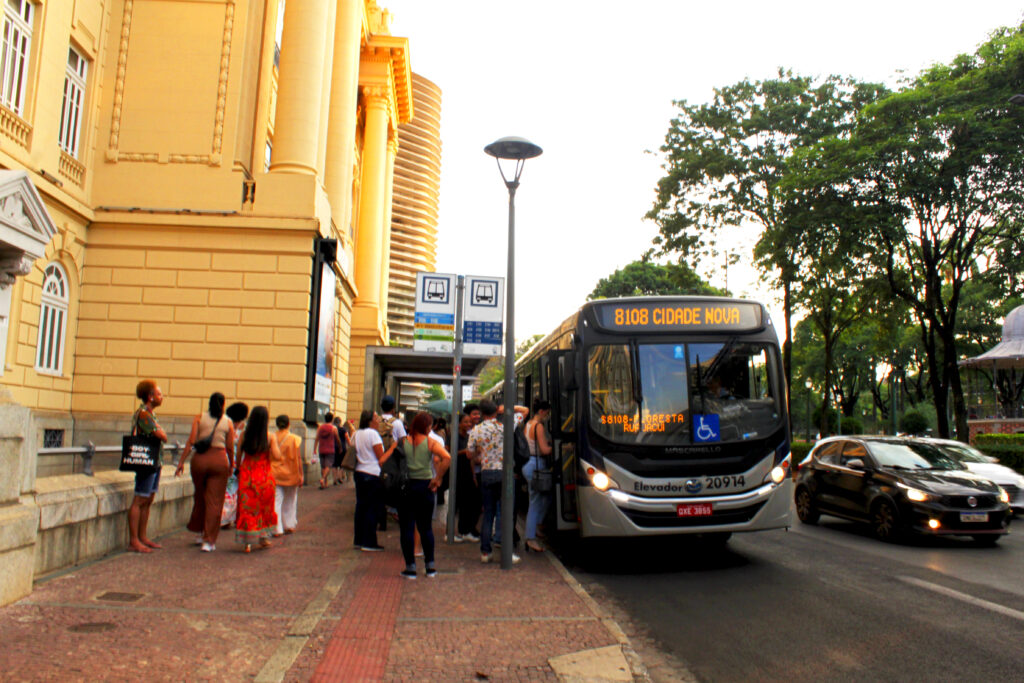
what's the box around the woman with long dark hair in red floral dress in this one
[234,405,281,553]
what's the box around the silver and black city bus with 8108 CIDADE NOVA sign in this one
[498,296,793,542]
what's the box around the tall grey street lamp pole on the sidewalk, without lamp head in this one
[502,179,519,569]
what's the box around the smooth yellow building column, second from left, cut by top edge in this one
[324,0,362,237]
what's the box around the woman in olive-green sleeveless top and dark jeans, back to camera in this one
[398,413,452,579]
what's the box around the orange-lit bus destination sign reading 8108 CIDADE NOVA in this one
[596,301,764,332]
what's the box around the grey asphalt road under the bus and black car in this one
[559,509,1024,682]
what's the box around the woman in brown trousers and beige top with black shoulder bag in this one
[174,391,234,553]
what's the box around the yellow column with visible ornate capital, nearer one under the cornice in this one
[352,86,388,341]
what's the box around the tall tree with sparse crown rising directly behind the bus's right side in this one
[647,69,885,411]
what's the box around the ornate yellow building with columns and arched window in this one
[0,0,414,602]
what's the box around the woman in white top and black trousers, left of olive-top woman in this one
[352,411,397,553]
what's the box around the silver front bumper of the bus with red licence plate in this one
[578,477,793,537]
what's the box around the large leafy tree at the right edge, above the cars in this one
[786,22,1024,438]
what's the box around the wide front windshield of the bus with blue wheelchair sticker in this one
[588,338,784,445]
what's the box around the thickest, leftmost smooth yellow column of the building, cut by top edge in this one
[270,0,330,175]
